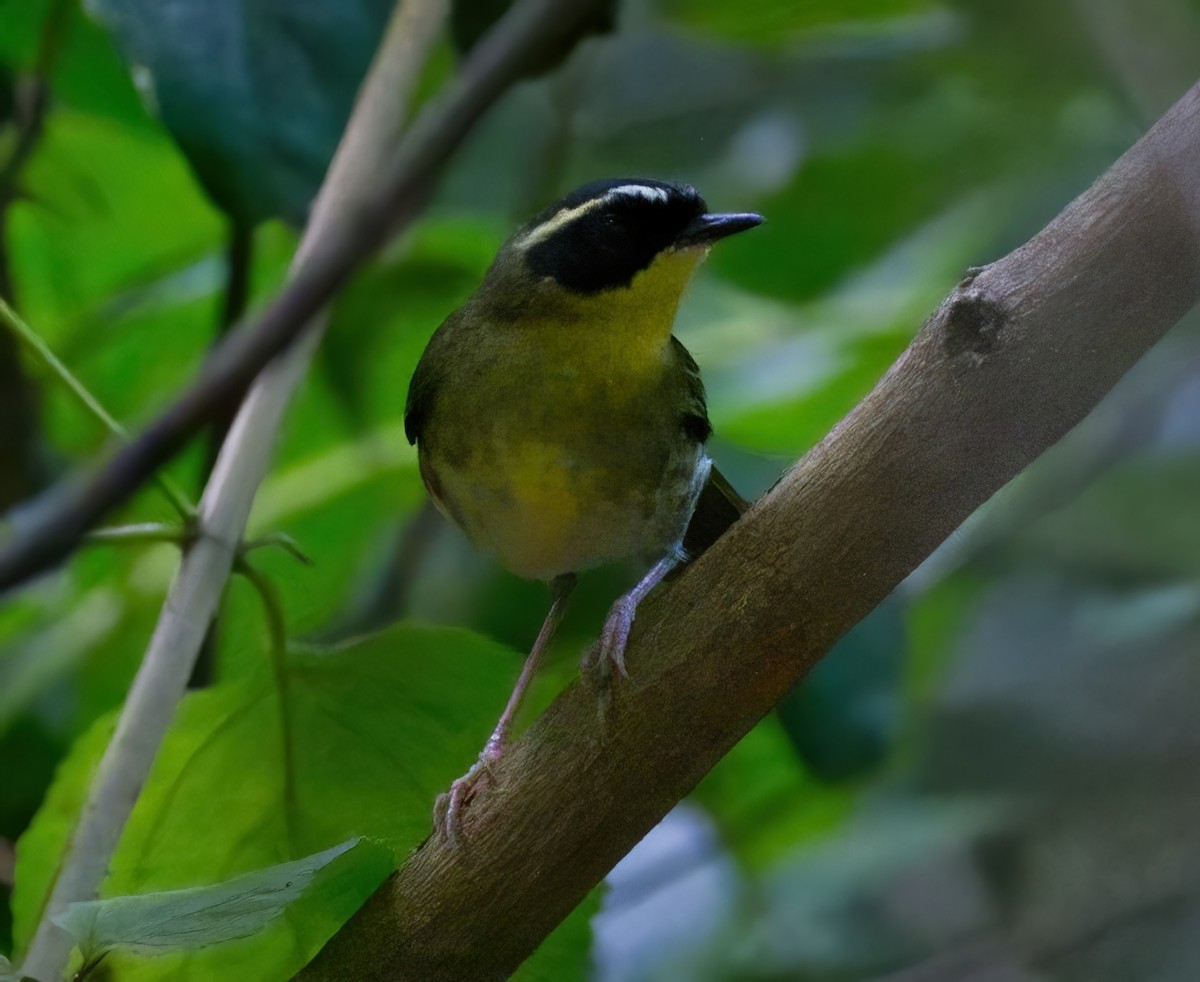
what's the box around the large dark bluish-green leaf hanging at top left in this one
[88,0,392,222]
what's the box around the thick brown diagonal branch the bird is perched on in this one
[298,78,1200,982]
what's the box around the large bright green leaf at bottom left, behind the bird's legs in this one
[13,624,530,982]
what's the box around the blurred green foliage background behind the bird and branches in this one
[0,0,1200,982]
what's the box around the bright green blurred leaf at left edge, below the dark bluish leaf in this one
[8,108,222,350]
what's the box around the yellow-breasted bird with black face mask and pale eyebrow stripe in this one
[404,178,763,843]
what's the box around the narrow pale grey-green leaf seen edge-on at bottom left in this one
[54,839,360,962]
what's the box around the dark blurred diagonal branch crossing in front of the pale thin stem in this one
[0,0,607,591]
